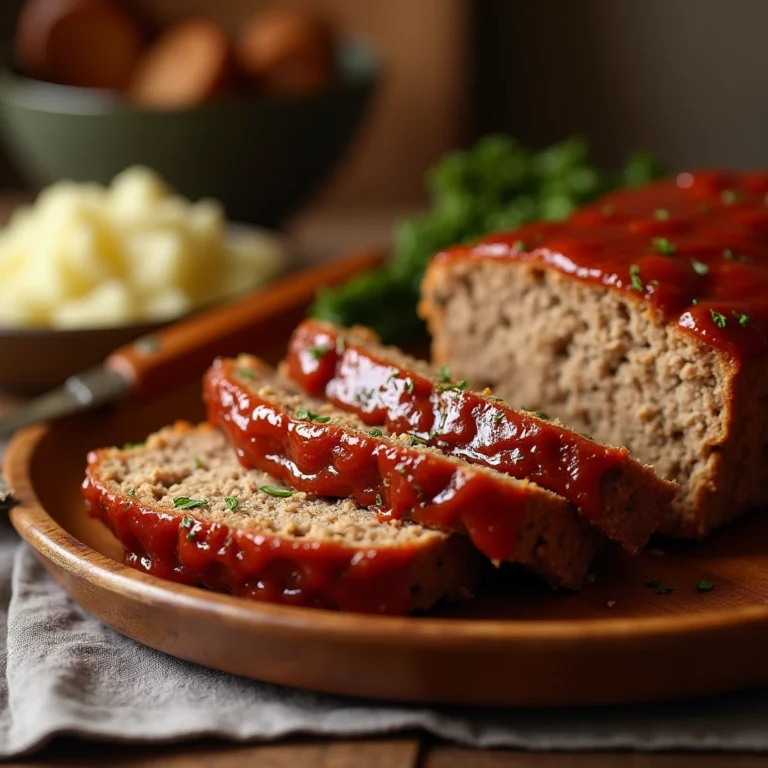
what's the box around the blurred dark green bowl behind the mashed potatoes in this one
[0,41,379,227]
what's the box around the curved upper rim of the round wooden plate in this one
[3,424,768,647]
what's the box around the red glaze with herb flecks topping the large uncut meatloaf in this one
[435,171,768,367]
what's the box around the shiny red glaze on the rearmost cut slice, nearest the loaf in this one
[286,320,674,533]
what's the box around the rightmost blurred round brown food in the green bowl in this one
[235,11,334,95]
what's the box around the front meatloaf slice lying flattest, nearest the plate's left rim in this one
[83,423,481,613]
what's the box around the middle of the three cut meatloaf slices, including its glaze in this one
[205,356,599,588]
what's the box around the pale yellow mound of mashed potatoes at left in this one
[0,167,283,328]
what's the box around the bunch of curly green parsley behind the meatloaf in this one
[311,136,660,342]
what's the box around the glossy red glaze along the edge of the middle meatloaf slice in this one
[204,360,548,560]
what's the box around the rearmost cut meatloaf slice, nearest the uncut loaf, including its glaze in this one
[285,320,675,552]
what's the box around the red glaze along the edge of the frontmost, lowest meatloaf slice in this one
[83,460,440,614]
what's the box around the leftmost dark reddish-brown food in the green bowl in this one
[16,0,143,89]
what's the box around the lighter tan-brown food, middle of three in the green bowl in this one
[129,19,229,109]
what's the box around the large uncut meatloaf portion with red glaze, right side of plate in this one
[421,172,768,537]
